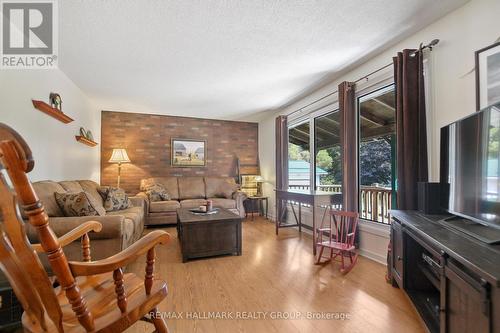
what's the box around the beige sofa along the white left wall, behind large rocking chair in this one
[26,180,144,260]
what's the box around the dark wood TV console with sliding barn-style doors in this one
[389,210,500,333]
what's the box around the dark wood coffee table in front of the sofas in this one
[177,208,243,262]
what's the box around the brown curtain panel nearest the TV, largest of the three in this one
[393,50,428,210]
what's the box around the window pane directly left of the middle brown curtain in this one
[314,110,342,193]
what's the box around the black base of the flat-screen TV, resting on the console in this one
[439,216,500,244]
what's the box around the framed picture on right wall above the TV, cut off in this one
[476,42,500,110]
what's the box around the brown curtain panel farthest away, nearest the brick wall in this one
[276,116,288,219]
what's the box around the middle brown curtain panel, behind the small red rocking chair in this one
[338,82,359,247]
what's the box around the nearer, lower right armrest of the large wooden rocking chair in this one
[69,230,170,276]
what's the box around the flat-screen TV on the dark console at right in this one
[441,104,500,228]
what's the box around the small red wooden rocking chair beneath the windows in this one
[316,208,358,274]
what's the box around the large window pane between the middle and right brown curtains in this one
[358,84,396,223]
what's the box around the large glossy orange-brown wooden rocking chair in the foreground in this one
[0,123,170,332]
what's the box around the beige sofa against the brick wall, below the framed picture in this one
[137,177,246,225]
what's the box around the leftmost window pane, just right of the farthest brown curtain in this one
[288,122,311,190]
